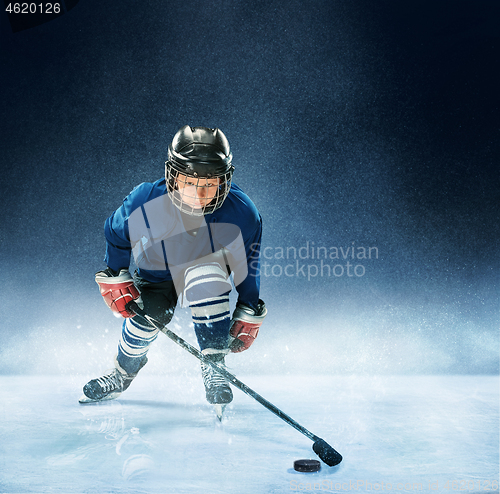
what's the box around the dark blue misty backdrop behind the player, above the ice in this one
[0,0,500,372]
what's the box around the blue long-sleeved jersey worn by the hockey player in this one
[104,179,262,308]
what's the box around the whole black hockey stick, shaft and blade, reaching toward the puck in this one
[127,302,342,467]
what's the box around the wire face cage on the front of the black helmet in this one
[165,160,234,216]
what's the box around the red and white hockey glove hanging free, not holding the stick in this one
[229,300,267,353]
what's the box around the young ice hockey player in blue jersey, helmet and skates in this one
[80,125,267,417]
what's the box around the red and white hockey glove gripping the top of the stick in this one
[95,268,142,317]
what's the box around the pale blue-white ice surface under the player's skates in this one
[0,376,499,494]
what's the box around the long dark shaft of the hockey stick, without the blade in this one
[127,302,320,441]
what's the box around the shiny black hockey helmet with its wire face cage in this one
[165,125,234,216]
